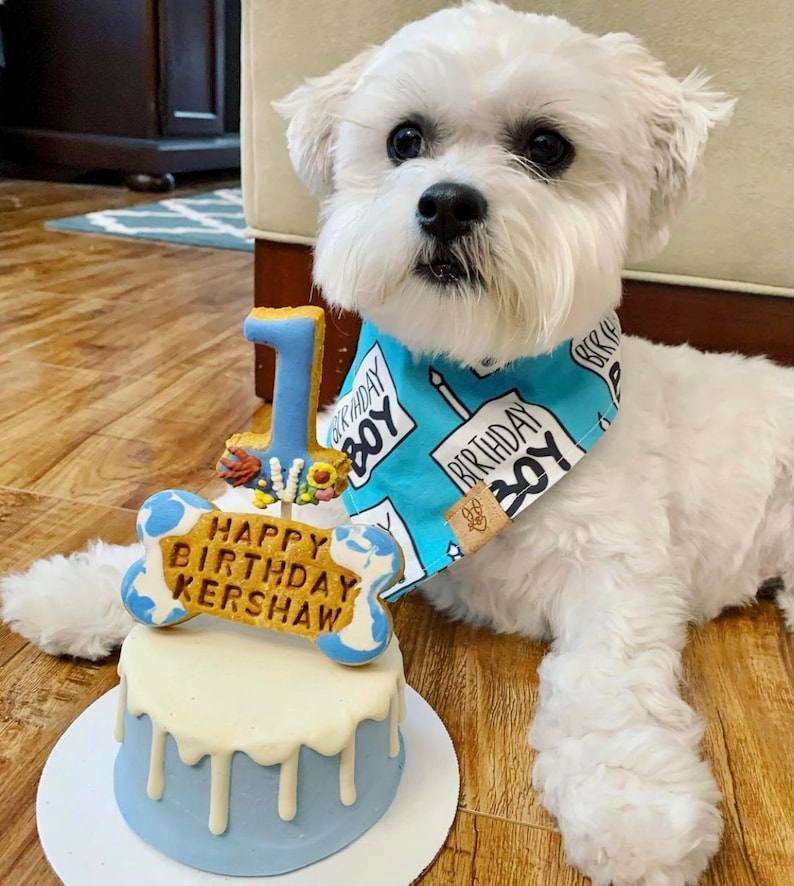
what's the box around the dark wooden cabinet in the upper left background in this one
[0,0,240,183]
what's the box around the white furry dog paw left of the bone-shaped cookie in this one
[0,541,143,660]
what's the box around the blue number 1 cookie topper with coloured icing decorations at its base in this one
[218,306,350,518]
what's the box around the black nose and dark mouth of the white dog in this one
[416,182,488,285]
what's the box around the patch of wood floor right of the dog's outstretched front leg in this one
[684,603,794,886]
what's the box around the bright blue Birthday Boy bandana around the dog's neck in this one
[328,313,620,600]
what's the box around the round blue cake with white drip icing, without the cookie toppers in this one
[114,616,405,876]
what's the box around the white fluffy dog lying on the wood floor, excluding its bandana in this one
[4,0,794,886]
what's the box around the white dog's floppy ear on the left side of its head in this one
[273,47,376,198]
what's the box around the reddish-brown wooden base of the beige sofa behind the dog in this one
[254,240,794,404]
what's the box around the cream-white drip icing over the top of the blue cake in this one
[116,616,405,834]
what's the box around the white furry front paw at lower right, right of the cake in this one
[534,734,722,886]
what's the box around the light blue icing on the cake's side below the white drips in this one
[114,713,405,877]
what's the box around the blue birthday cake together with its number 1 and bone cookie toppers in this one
[114,308,405,876]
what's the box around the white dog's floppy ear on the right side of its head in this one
[601,34,736,261]
